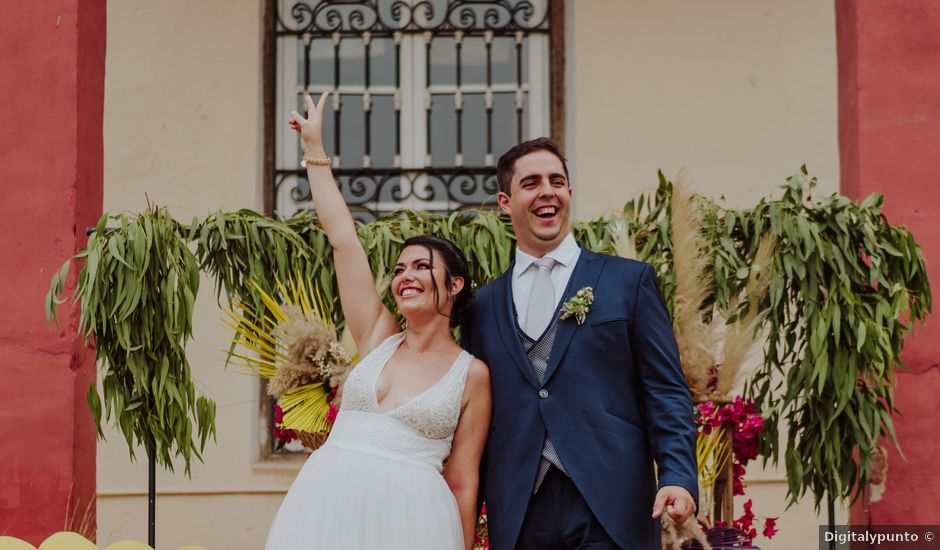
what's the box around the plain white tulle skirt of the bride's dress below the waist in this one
[265,443,463,550]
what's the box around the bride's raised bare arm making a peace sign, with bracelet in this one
[289,92,401,356]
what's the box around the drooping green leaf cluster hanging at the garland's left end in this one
[46,208,215,475]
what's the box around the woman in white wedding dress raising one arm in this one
[265,93,490,550]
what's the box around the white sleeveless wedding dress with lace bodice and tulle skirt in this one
[265,333,472,550]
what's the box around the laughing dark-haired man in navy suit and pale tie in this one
[463,138,697,550]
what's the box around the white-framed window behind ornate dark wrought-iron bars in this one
[265,0,561,221]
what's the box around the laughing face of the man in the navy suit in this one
[497,151,571,257]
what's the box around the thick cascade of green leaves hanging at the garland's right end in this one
[724,171,931,508]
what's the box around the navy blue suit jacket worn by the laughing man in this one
[462,248,698,550]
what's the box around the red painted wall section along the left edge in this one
[0,0,105,545]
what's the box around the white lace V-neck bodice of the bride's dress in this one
[326,332,473,471]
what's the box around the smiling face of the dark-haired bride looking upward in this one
[391,246,459,318]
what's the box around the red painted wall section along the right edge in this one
[836,0,940,525]
